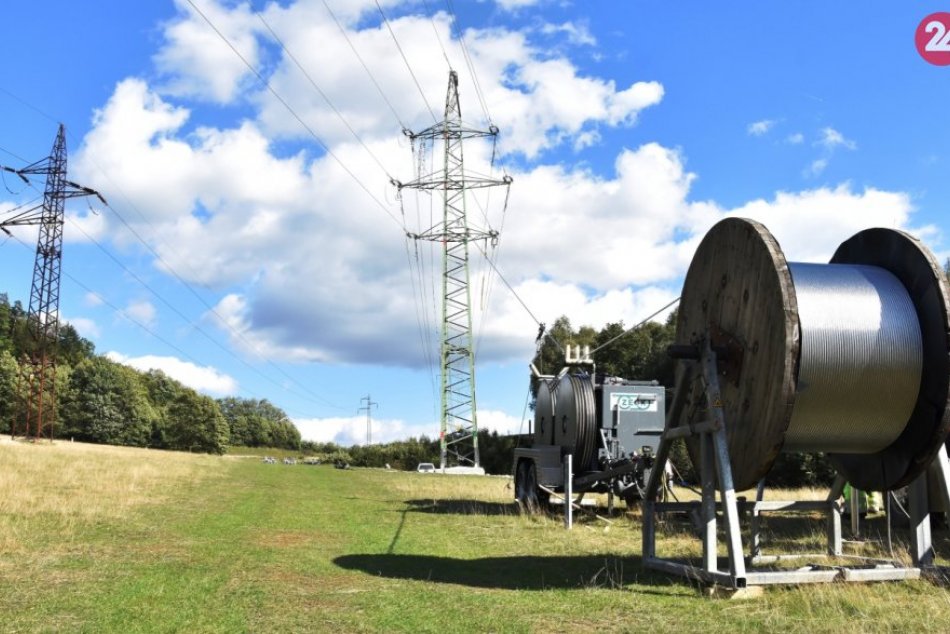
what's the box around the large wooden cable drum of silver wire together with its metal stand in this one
[643,218,950,588]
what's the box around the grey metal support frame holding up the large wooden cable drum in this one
[642,340,936,589]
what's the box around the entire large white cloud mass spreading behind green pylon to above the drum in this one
[74,1,928,380]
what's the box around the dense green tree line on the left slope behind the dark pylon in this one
[0,293,301,454]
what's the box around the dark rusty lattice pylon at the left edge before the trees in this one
[0,124,107,440]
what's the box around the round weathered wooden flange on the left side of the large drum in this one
[668,218,799,490]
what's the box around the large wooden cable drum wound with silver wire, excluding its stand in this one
[668,218,950,490]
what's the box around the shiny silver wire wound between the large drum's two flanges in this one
[784,262,923,454]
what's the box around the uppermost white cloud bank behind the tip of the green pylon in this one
[186,2,663,156]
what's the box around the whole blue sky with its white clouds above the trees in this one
[0,0,950,444]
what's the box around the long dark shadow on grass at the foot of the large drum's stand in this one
[333,555,689,594]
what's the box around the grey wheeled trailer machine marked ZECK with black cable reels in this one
[514,346,666,512]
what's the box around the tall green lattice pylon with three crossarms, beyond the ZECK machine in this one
[394,70,511,469]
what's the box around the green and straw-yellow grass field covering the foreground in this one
[0,440,950,632]
